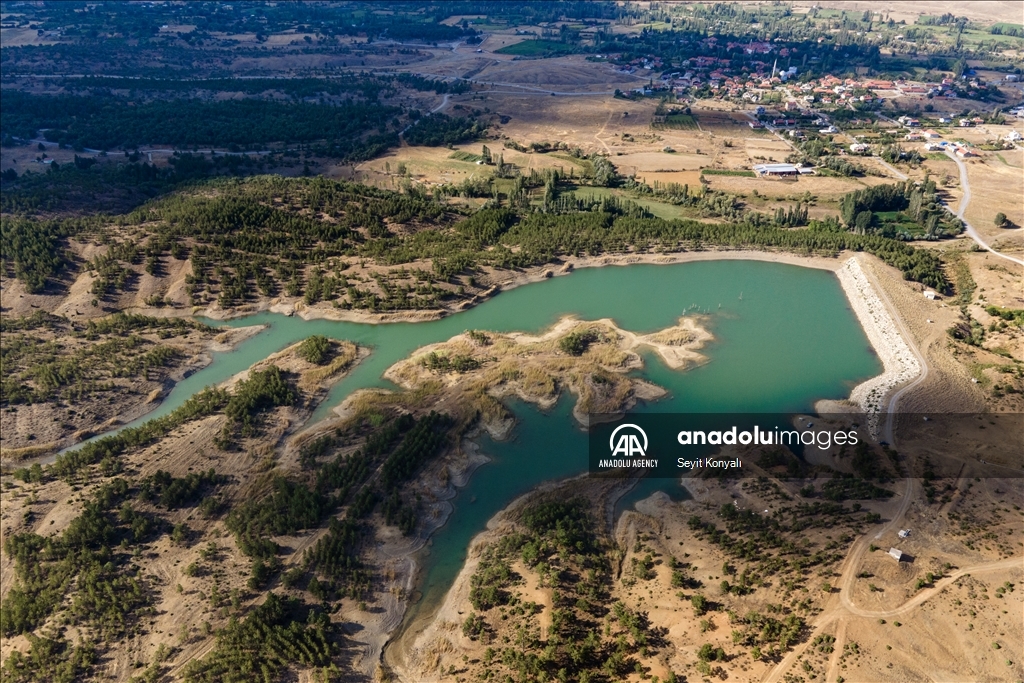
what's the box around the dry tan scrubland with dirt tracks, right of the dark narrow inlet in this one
[386,454,1024,682]
